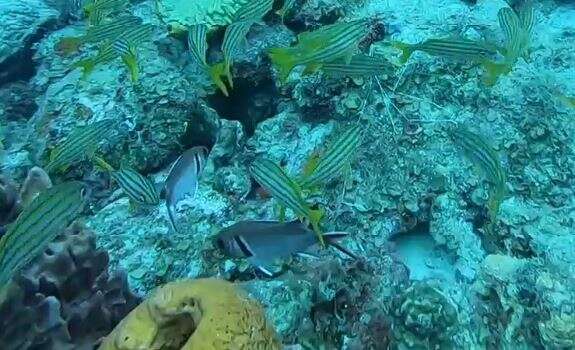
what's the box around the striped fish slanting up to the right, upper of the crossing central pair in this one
[298,125,361,188]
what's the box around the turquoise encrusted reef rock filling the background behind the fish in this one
[0,0,575,349]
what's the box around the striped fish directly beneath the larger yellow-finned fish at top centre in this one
[321,54,393,77]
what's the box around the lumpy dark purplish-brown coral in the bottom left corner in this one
[0,225,139,350]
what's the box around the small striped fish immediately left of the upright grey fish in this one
[94,157,160,205]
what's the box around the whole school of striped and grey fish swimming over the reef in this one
[0,0,536,286]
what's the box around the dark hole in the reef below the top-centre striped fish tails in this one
[208,76,279,137]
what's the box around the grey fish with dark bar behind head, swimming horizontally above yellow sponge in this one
[215,220,357,277]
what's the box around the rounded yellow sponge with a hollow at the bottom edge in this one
[100,278,281,350]
